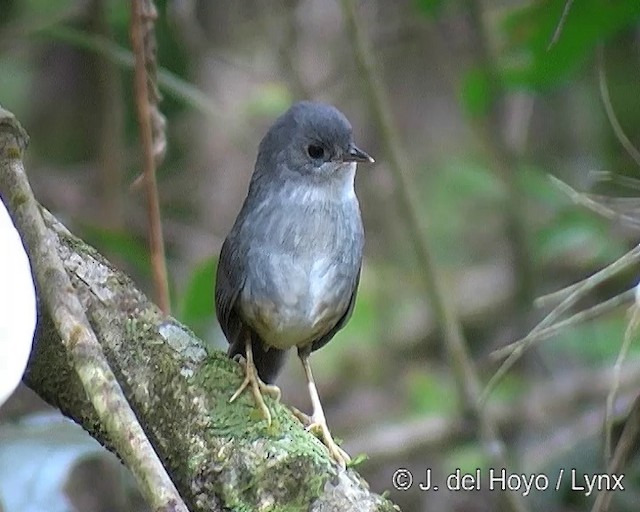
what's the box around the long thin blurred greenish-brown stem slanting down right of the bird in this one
[342,0,527,511]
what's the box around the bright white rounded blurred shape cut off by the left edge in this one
[0,196,36,406]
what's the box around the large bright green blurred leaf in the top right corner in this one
[502,0,640,89]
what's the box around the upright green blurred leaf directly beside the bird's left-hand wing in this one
[178,258,218,337]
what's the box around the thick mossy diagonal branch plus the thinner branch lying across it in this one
[0,107,397,512]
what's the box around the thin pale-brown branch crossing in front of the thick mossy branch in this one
[0,108,187,512]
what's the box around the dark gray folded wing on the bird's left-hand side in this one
[215,236,246,344]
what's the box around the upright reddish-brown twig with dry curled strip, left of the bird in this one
[131,0,171,314]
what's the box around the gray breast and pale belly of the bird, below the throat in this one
[240,190,363,349]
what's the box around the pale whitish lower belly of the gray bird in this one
[240,254,357,349]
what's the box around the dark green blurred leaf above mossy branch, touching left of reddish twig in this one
[82,225,151,277]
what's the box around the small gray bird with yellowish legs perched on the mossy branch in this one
[215,101,373,466]
